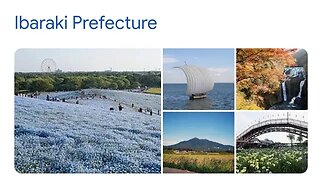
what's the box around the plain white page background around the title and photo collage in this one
[0,0,320,180]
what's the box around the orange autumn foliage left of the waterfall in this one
[236,48,296,109]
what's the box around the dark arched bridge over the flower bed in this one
[237,118,308,148]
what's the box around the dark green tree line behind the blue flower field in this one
[15,71,161,94]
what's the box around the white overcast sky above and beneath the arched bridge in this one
[236,111,308,143]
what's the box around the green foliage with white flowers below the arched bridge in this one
[237,147,308,173]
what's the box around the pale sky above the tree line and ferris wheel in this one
[15,49,161,72]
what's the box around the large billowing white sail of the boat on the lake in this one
[177,65,214,96]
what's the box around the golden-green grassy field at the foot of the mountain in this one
[163,153,234,173]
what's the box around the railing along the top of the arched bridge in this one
[237,118,308,139]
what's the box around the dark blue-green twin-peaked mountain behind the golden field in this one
[164,138,234,152]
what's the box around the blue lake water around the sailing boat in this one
[163,83,234,110]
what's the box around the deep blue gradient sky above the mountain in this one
[163,112,234,145]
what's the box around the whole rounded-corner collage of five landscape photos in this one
[14,48,308,174]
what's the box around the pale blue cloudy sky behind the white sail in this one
[163,49,234,83]
